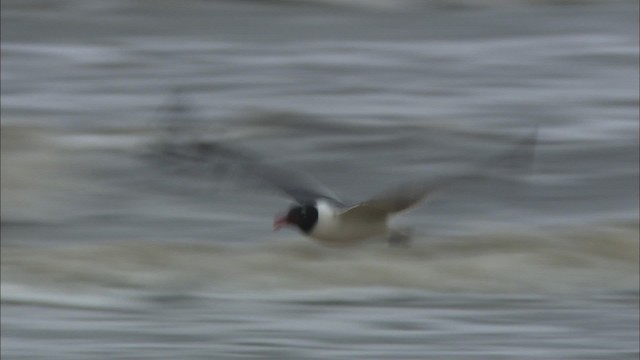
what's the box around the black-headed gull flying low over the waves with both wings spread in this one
[148,91,538,246]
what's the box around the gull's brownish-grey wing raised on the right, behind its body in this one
[342,128,538,217]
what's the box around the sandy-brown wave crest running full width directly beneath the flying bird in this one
[1,222,639,307]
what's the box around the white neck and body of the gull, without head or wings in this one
[309,200,389,246]
